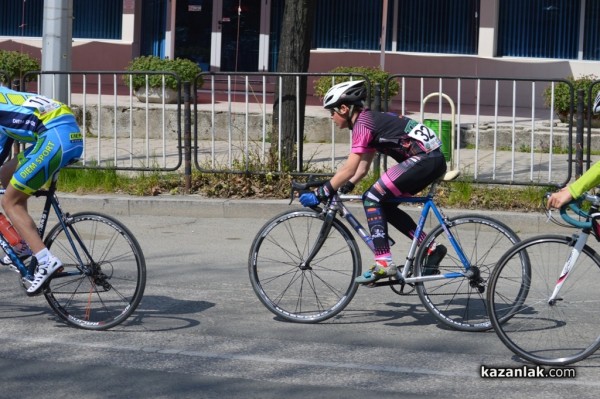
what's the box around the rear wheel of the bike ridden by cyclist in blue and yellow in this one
[43,212,146,330]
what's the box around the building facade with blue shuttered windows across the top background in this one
[0,0,600,79]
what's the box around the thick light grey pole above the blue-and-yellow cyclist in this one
[41,0,73,103]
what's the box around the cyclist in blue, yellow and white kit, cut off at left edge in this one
[0,87,83,295]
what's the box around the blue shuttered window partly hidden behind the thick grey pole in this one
[0,0,123,39]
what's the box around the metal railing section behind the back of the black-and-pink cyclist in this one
[386,75,575,184]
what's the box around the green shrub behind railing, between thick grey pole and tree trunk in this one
[123,55,203,90]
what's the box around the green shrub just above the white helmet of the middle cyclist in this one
[314,67,400,101]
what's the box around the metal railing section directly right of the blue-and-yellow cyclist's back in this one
[22,71,183,171]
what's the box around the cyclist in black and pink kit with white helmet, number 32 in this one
[300,80,446,284]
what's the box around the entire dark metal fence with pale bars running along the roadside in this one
[1,71,600,185]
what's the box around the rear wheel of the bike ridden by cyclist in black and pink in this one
[413,215,519,331]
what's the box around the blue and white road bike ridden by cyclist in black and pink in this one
[248,173,519,331]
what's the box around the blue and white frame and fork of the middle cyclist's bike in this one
[314,183,472,283]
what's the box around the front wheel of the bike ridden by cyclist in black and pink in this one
[248,210,362,323]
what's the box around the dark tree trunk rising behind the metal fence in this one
[271,0,316,170]
